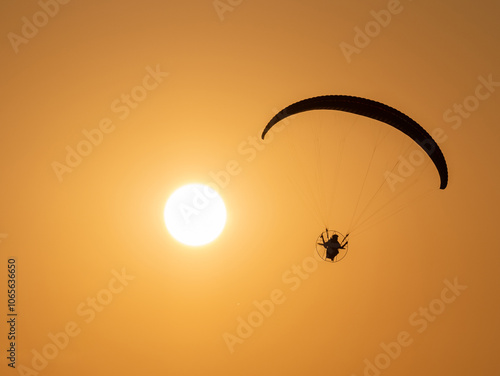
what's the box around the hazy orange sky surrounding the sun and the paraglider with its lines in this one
[0,0,500,376]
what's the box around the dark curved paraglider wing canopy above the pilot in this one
[262,95,448,189]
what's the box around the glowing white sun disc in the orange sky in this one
[164,184,227,246]
